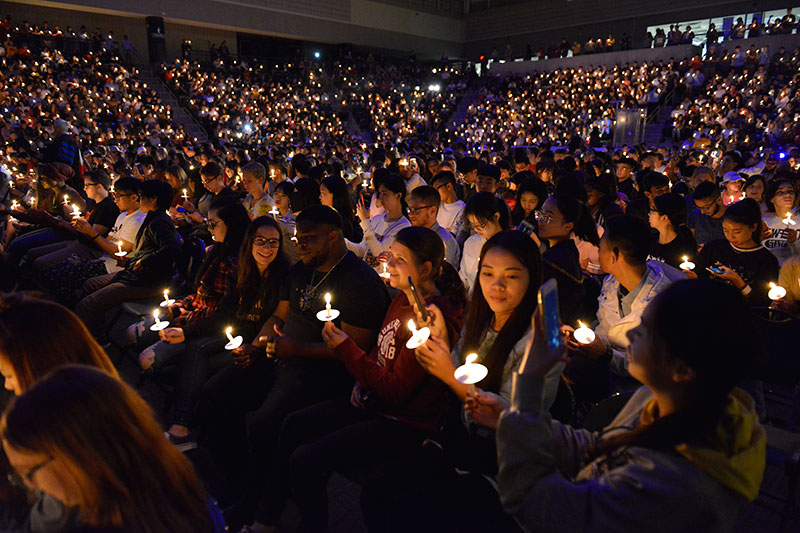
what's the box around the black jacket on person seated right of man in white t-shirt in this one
[114,211,181,287]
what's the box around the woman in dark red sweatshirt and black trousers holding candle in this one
[242,227,466,531]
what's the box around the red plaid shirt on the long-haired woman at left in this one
[175,252,238,326]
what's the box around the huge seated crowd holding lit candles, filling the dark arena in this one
[0,7,800,533]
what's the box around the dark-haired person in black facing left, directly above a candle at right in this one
[648,192,697,268]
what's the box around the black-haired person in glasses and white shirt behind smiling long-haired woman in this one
[458,192,511,292]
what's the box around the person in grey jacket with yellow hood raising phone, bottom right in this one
[497,281,766,531]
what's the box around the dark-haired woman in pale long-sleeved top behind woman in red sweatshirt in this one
[345,176,411,267]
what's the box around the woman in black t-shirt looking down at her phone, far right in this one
[689,198,779,307]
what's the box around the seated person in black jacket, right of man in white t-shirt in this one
[75,180,181,338]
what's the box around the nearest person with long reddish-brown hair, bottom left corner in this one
[0,365,225,533]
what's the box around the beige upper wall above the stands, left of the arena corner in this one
[0,0,466,58]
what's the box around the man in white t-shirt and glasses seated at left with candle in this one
[37,178,145,307]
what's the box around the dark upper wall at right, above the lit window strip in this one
[464,0,800,59]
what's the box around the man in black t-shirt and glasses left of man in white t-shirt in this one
[25,169,119,272]
